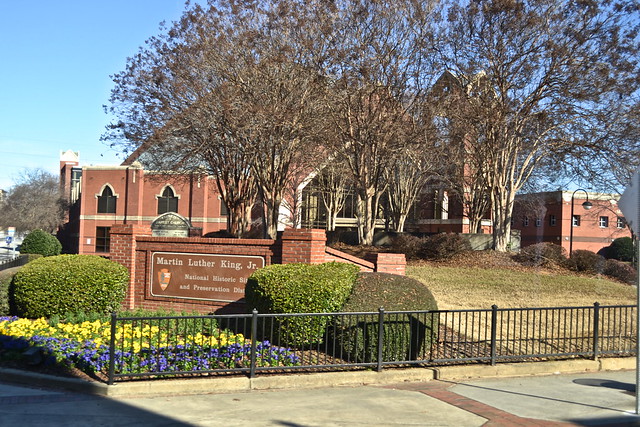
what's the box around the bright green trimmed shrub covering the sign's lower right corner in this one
[245,262,359,346]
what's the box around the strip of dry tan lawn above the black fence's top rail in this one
[407,254,636,310]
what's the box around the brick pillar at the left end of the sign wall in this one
[110,224,151,310]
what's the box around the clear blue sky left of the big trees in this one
[0,0,195,190]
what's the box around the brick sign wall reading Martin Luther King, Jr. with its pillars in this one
[111,224,405,314]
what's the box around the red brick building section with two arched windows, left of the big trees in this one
[59,150,227,256]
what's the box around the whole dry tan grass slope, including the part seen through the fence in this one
[407,252,636,354]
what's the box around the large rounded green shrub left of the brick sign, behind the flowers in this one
[13,255,129,318]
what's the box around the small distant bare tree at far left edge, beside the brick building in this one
[0,169,66,233]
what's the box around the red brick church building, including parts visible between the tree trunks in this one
[58,150,491,256]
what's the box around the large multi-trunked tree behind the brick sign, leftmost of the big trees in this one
[104,0,324,238]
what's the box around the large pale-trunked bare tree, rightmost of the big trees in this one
[439,0,640,251]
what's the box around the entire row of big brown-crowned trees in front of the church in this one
[104,0,640,250]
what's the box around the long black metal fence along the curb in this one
[108,303,637,384]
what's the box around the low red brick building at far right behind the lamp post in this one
[512,190,631,253]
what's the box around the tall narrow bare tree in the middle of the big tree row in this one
[308,1,442,244]
